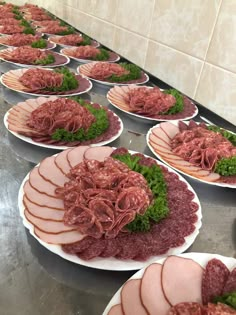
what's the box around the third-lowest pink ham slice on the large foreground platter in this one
[23,195,65,221]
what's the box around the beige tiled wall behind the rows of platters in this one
[28,0,236,124]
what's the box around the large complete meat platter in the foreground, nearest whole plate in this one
[18,146,202,270]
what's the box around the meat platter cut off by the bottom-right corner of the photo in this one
[103,253,236,315]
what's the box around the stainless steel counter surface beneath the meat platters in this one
[0,55,236,315]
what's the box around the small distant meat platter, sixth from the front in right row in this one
[48,34,99,47]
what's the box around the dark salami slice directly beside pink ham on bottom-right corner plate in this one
[202,258,230,304]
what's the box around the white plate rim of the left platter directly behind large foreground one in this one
[4,98,124,150]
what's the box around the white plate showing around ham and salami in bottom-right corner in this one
[102,253,236,315]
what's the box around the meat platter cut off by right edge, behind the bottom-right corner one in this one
[146,120,236,188]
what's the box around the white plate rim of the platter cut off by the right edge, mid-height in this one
[146,120,236,188]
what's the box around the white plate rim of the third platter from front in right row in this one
[107,85,198,122]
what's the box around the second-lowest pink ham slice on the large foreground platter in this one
[24,209,75,234]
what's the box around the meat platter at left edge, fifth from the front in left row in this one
[0,34,56,49]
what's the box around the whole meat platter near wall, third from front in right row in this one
[107,85,198,122]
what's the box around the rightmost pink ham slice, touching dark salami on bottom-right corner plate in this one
[162,256,203,305]
